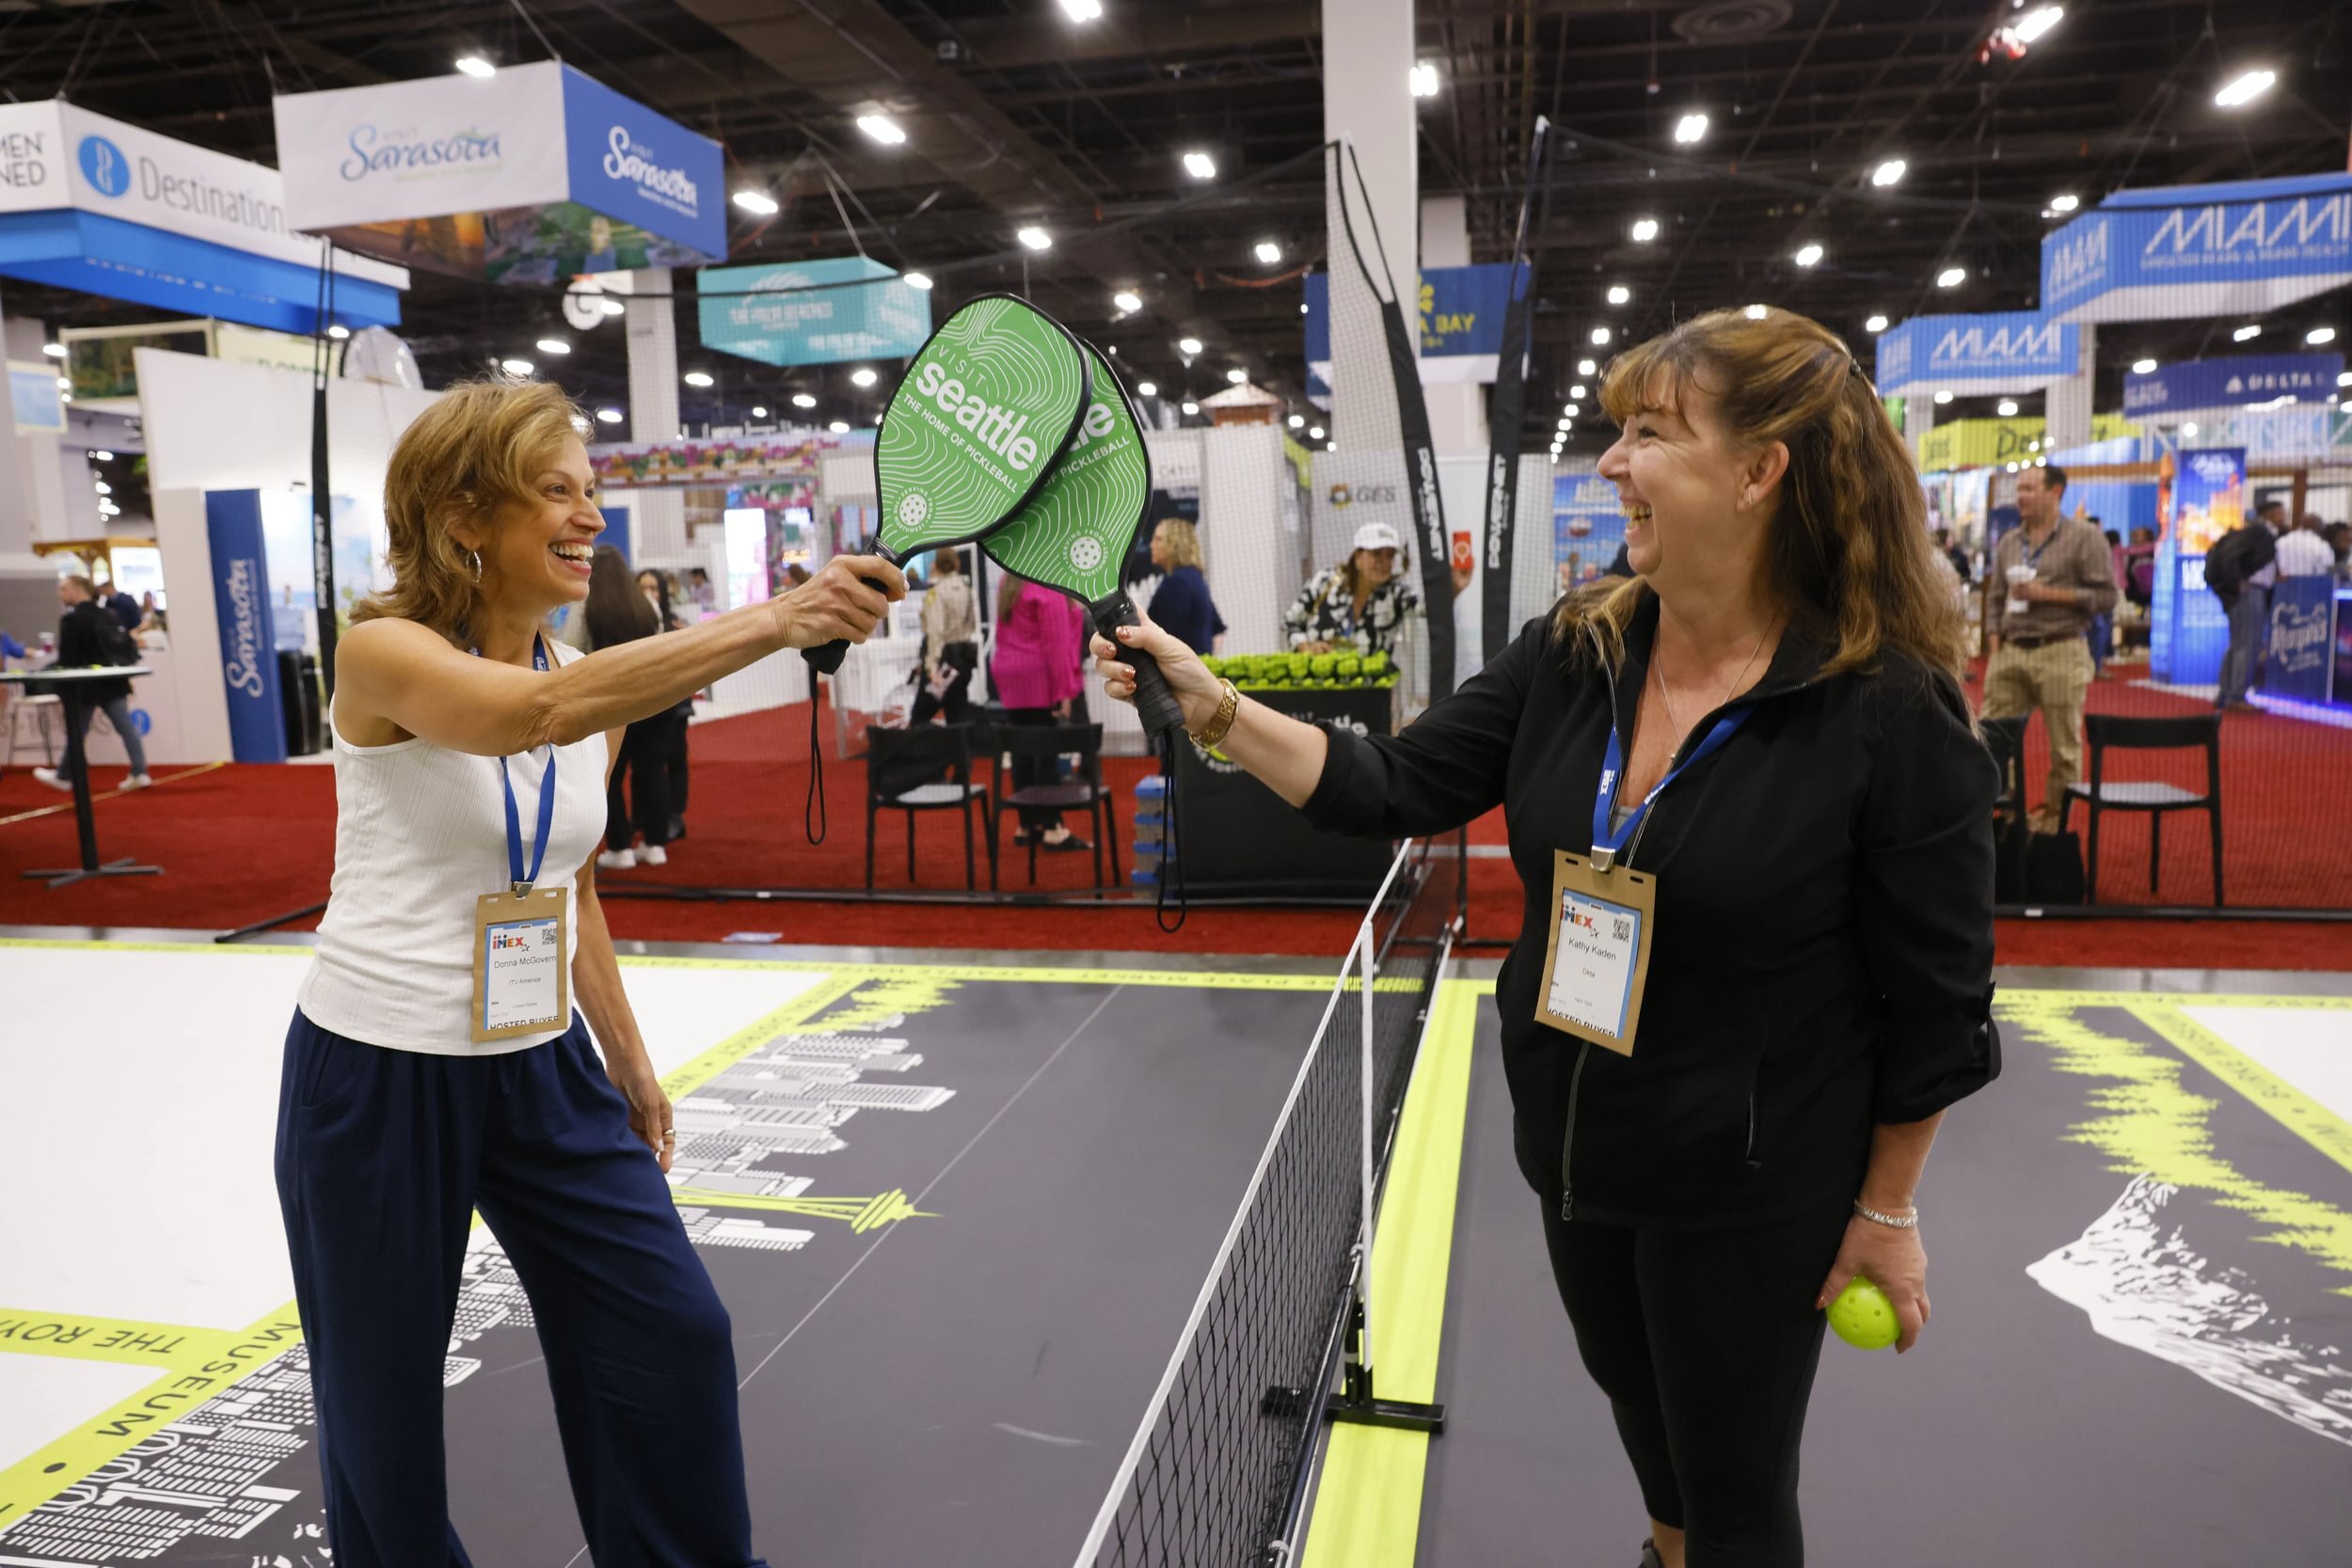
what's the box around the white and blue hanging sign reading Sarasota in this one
[271,61,727,284]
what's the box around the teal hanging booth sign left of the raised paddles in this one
[694,256,931,364]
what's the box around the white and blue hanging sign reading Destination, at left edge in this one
[0,101,409,334]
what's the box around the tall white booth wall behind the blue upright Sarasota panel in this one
[131,348,437,764]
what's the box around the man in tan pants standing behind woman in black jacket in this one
[1985,467,2117,832]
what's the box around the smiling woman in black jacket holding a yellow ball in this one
[1094,310,1999,1568]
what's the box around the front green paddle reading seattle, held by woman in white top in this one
[804,293,1091,674]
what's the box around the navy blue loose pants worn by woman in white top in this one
[278,1011,760,1568]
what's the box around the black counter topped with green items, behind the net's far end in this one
[1176,687,1395,903]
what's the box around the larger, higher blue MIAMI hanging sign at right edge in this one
[2042,174,2352,322]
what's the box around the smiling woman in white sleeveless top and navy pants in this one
[278,381,906,1568]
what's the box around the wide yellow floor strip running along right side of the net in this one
[1306,980,1494,1568]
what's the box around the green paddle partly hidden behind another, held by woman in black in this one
[981,343,1184,740]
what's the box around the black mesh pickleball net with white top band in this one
[1075,842,1454,1568]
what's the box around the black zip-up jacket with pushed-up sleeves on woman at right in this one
[1306,597,2002,1229]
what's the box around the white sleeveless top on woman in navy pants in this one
[296,637,605,1055]
